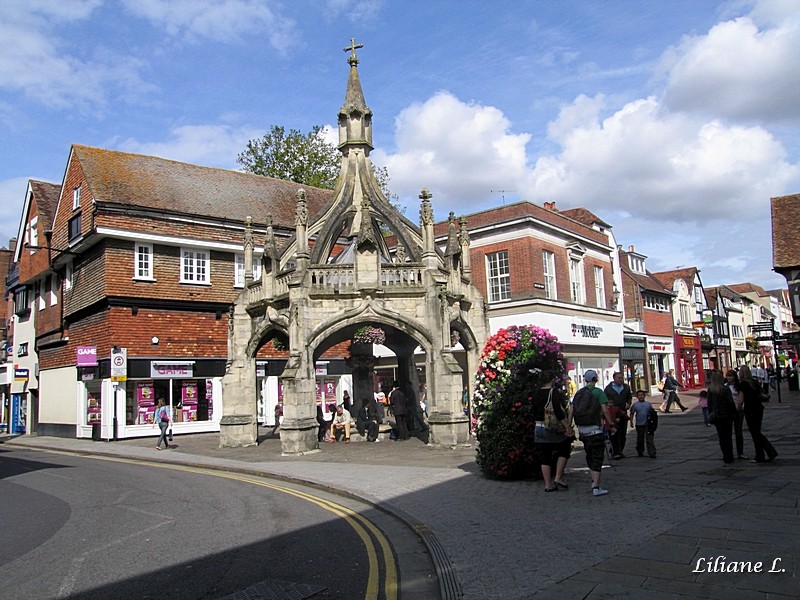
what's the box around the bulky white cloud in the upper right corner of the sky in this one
[661,8,800,122]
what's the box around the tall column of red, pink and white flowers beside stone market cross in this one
[473,325,565,479]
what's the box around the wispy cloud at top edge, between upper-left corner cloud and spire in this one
[124,0,295,52]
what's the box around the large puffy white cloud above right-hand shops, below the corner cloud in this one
[527,97,800,223]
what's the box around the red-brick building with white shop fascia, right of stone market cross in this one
[436,202,623,385]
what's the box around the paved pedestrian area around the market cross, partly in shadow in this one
[3,383,800,600]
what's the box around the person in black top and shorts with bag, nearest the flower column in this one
[533,371,575,492]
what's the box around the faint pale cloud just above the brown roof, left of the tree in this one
[114,124,263,169]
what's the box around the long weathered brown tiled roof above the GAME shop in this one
[73,145,333,228]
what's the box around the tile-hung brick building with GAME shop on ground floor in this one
[13,145,338,439]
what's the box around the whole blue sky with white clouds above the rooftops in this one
[0,0,800,288]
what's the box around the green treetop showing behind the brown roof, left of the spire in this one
[236,125,342,189]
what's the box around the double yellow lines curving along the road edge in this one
[45,450,397,600]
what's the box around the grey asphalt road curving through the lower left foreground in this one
[0,447,438,600]
